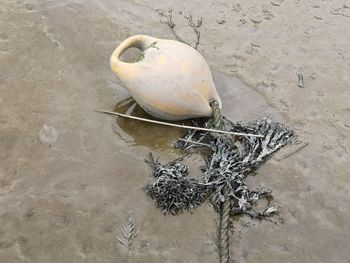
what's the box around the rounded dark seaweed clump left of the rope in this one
[145,154,206,215]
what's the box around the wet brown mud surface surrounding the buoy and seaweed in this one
[0,0,350,263]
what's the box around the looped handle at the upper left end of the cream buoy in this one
[110,35,156,74]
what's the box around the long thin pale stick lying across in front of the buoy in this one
[95,110,264,137]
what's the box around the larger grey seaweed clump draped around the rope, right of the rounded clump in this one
[204,119,294,218]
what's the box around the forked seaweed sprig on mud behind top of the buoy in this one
[159,8,202,49]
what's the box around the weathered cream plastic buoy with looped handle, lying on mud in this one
[110,35,221,120]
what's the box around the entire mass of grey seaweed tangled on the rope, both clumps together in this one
[146,118,295,219]
